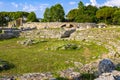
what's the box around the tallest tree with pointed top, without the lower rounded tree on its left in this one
[75,1,98,22]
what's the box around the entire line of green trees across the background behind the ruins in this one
[0,1,120,26]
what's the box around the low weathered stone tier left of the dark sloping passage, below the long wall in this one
[20,29,65,39]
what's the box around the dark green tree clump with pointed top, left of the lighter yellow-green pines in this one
[67,1,98,22]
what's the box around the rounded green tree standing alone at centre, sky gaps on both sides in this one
[44,4,65,22]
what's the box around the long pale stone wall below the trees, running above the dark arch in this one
[21,22,97,30]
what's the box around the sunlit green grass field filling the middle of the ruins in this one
[0,38,108,75]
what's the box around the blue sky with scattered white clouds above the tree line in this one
[0,0,120,18]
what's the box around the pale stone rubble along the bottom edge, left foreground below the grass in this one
[0,72,56,80]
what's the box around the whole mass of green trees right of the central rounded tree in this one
[66,1,120,25]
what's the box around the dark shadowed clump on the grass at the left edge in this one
[0,60,15,72]
